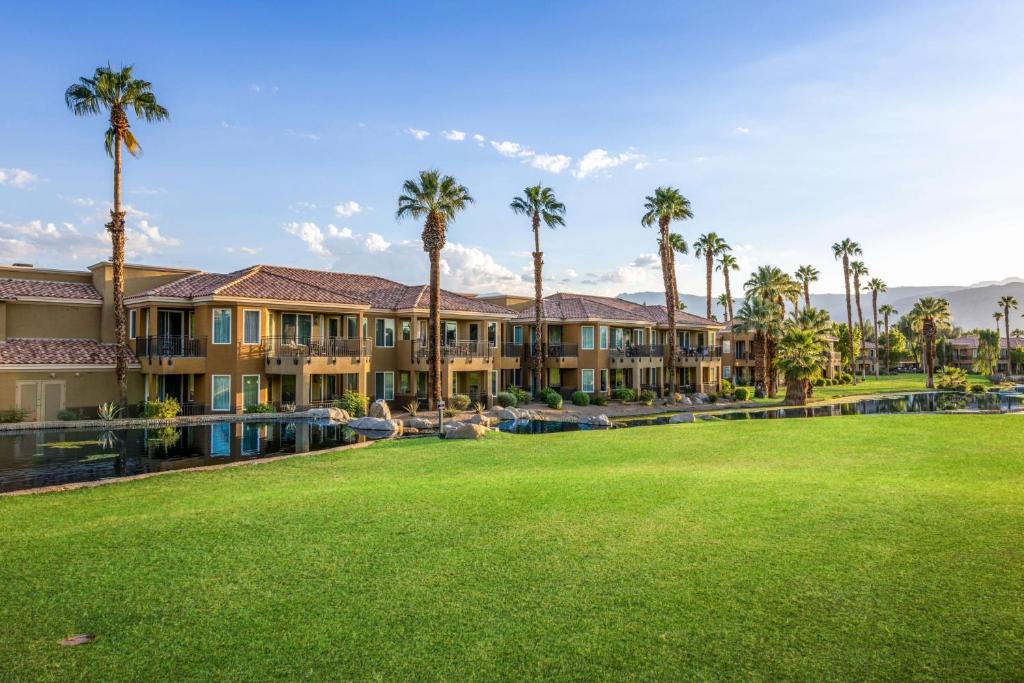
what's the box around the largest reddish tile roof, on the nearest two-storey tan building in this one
[127,265,514,315]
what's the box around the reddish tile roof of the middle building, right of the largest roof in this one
[516,294,722,327]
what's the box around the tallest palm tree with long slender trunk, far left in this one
[65,65,170,412]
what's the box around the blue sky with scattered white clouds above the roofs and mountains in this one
[0,2,1024,294]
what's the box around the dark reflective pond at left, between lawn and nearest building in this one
[0,421,367,492]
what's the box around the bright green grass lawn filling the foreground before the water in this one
[0,415,1024,681]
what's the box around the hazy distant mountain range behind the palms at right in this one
[618,278,1024,330]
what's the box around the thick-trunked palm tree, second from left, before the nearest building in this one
[395,169,473,410]
